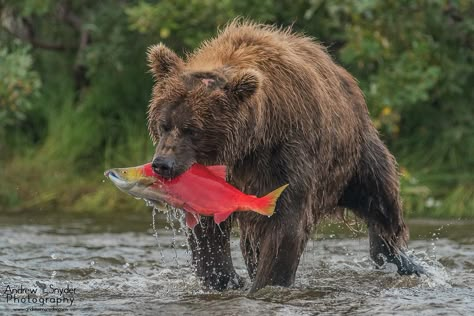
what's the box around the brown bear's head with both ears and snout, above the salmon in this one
[148,44,261,178]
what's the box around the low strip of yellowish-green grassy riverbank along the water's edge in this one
[0,168,474,219]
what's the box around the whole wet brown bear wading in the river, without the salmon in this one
[148,21,422,291]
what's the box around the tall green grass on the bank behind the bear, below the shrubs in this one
[0,63,474,218]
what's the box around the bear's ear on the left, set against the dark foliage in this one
[147,43,183,81]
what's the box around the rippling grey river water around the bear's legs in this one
[0,212,474,315]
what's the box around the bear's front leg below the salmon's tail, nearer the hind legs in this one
[250,205,312,293]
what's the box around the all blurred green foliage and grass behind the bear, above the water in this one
[0,0,474,217]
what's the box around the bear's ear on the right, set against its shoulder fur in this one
[224,69,262,101]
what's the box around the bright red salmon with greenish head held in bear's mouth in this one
[104,163,288,228]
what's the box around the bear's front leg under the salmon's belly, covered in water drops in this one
[188,217,243,291]
